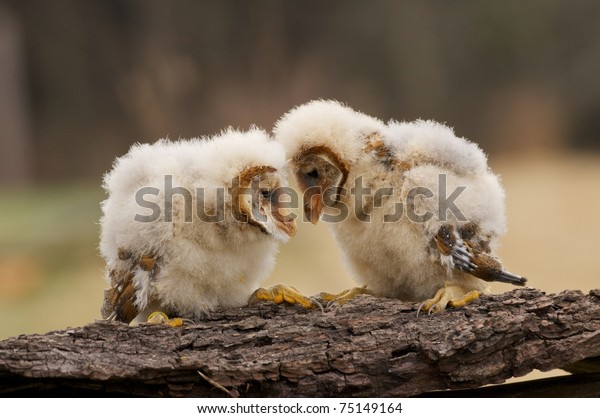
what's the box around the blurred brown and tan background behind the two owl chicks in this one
[0,0,600,382]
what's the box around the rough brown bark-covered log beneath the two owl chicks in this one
[0,288,600,397]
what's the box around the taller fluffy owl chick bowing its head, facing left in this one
[274,100,526,312]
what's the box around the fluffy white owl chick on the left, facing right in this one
[100,128,310,323]
